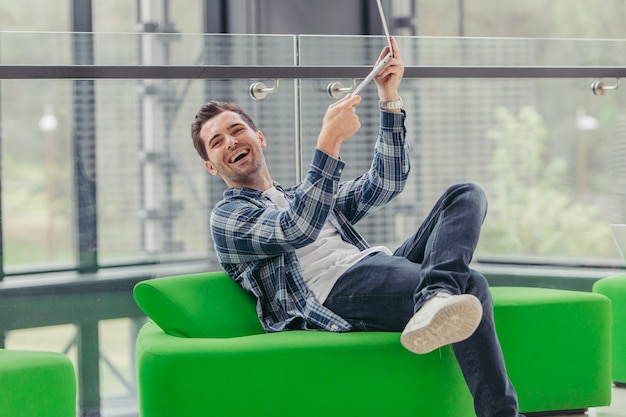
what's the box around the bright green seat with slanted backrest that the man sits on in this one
[135,272,473,417]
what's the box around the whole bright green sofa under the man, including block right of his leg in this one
[134,272,611,417]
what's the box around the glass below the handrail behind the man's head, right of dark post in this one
[96,80,296,267]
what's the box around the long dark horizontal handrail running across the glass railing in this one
[0,65,626,80]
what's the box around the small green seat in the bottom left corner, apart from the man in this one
[0,349,76,417]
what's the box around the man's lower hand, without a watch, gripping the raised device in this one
[317,95,361,158]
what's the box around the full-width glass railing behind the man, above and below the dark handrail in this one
[0,33,626,274]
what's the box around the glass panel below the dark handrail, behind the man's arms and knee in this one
[302,75,626,265]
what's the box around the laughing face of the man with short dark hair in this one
[200,111,266,188]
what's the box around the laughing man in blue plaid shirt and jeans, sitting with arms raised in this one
[192,40,519,417]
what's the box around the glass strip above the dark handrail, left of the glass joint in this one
[0,32,295,65]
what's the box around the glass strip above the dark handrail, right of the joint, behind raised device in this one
[299,35,626,67]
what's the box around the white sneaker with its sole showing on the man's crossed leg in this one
[400,292,483,353]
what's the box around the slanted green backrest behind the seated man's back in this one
[133,272,264,338]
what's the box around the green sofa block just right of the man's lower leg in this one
[491,287,611,413]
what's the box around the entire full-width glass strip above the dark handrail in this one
[0,32,626,66]
